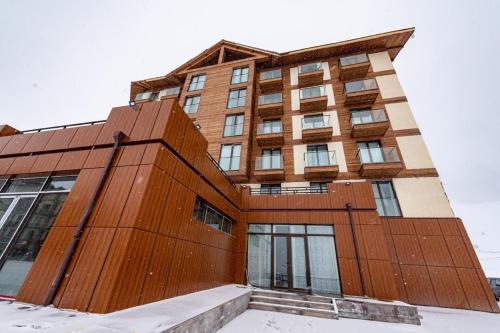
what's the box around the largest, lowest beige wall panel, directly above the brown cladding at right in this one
[392,177,455,217]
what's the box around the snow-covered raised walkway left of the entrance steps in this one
[0,285,248,333]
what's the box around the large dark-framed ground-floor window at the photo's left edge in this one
[0,176,76,296]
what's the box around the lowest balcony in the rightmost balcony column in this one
[358,147,403,177]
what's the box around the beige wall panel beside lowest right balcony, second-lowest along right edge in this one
[396,135,434,169]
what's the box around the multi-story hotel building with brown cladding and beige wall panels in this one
[0,28,498,312]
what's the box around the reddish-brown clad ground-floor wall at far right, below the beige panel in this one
[382,218,499,312]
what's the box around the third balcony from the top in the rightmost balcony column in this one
[351,109,389,138]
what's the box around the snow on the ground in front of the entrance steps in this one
[218,306,500,333]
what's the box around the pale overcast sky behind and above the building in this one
[0,0,500,276]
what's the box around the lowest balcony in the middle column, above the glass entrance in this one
[304,150,339,179]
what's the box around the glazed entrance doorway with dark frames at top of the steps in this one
[247,224,341,295]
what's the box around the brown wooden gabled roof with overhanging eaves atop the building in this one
[130,28,415,99]
